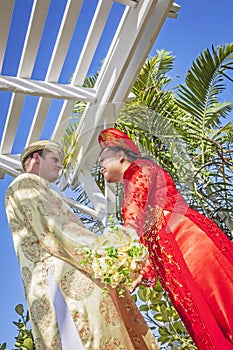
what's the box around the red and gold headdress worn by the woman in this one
[98,128,141,155]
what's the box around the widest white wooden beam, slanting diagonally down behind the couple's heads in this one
[68,0,173,179]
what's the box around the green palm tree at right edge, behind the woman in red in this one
[174,43,233,238]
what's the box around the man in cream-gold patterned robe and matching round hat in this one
[6,140,158,350]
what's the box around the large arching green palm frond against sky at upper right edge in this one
[177,44,233,131]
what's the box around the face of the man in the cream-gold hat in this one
[39,152,63,182]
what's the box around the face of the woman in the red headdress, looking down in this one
[100,148,125,182]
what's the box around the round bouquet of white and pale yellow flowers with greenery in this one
[83,225,148,296]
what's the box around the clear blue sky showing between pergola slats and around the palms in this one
[0,0,233,348]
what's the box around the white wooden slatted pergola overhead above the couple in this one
[0,0,179,221]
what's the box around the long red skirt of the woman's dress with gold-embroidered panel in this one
[144,208,233,350]
